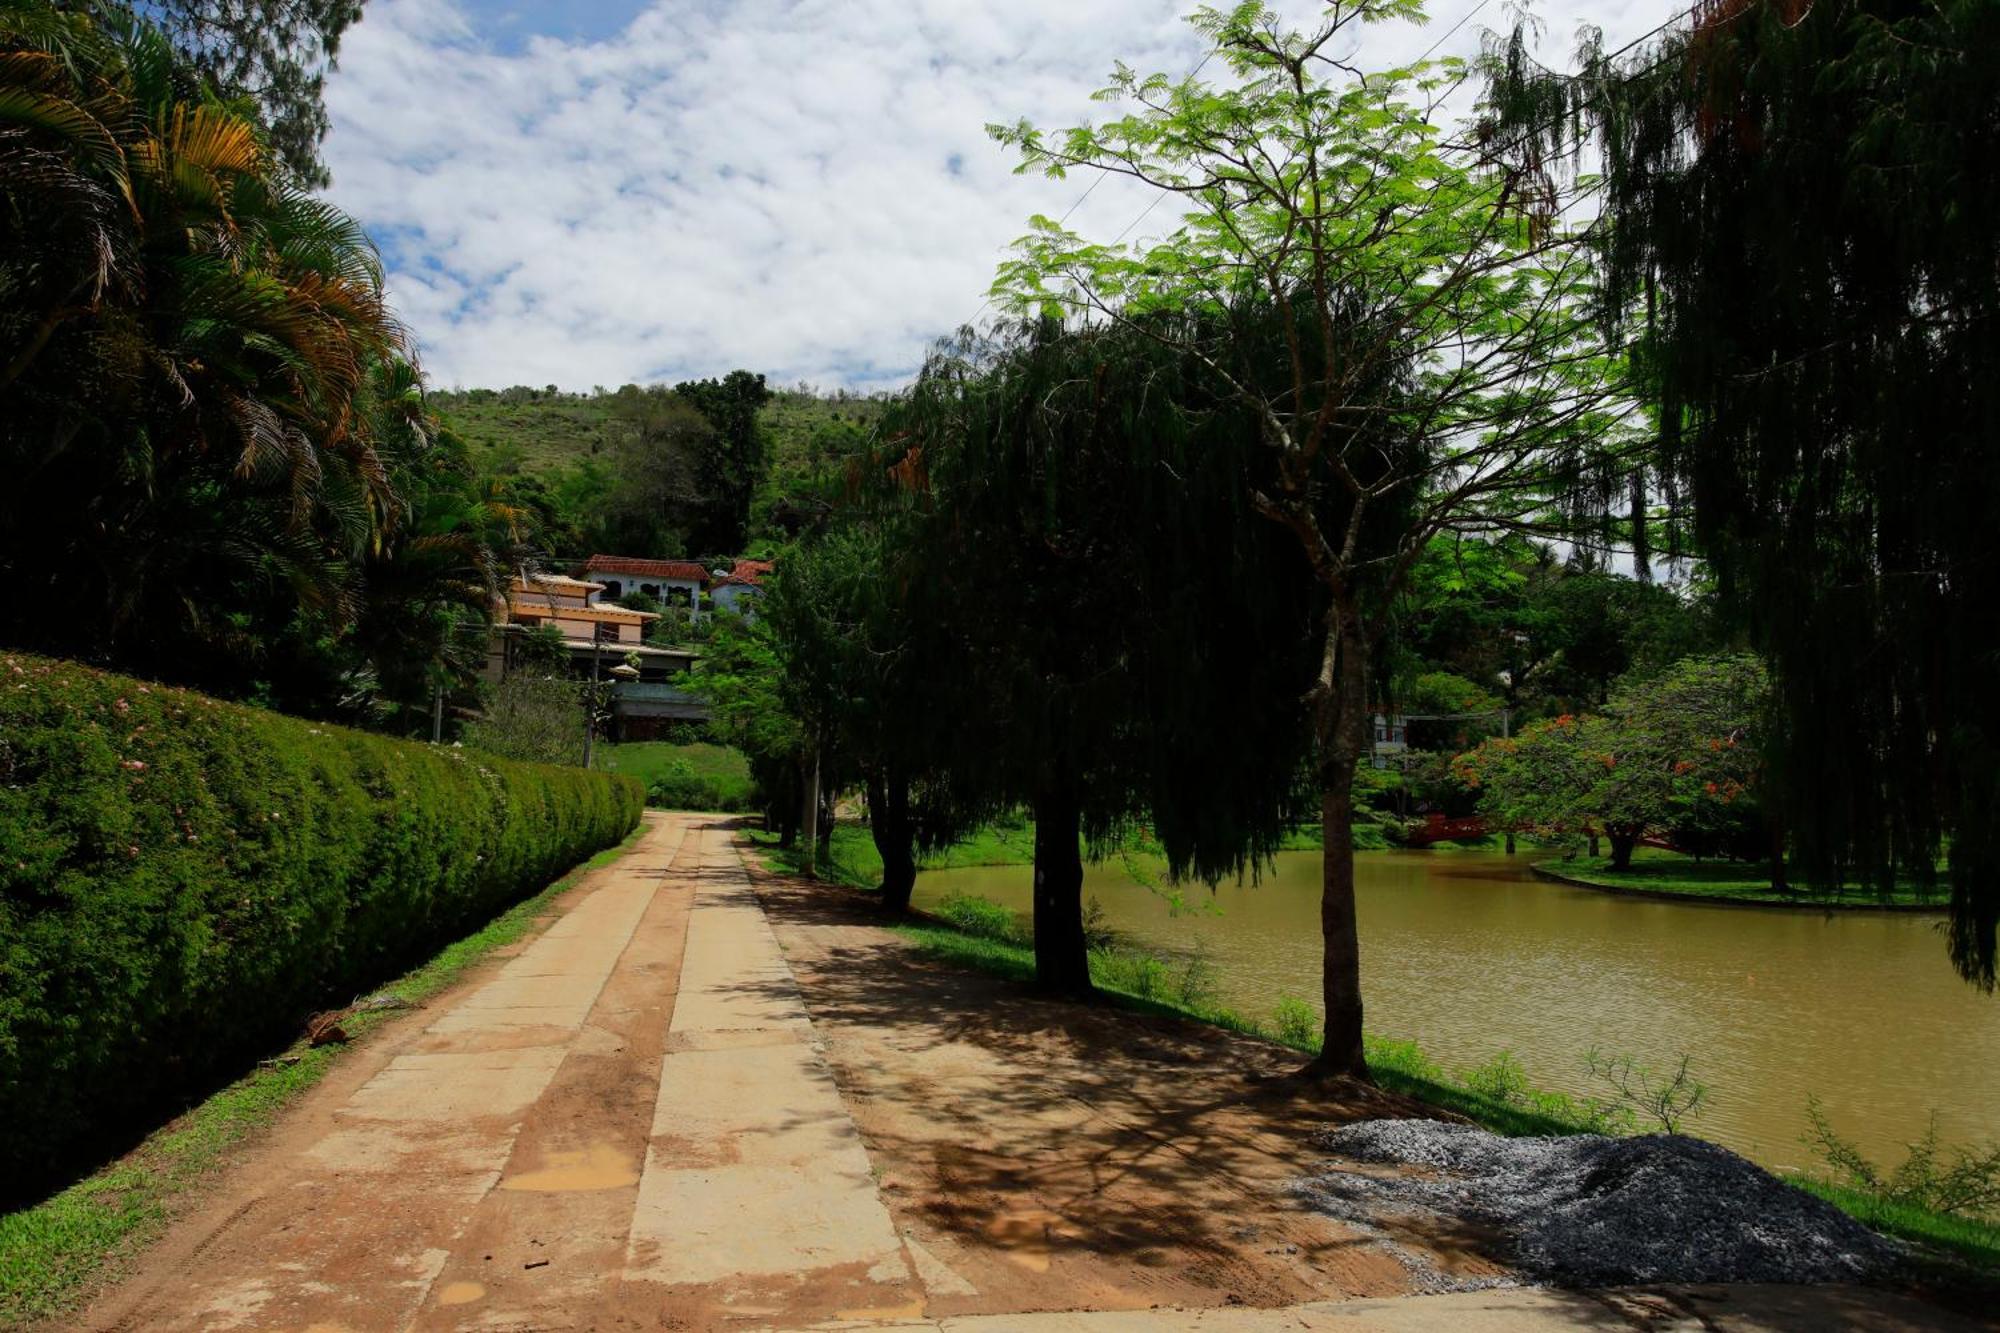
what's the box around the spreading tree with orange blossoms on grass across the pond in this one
[1452,652,1770,869]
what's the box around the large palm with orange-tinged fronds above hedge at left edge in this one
[0,15,386,677]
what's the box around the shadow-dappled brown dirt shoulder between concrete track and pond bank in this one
[752,852,1506,1315]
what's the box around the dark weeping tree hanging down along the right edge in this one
[1486,0,2000,991]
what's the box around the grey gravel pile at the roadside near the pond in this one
[1296,1121,1896,1283]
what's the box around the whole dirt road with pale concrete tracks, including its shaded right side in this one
[72,815,1970,1333]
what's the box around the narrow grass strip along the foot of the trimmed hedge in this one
[0,829,642,1325]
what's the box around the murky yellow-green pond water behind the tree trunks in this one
[916,853,2000,1167]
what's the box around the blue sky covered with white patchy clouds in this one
[326,0,1656,388]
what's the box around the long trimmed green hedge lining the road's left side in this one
[0,652,644,1195]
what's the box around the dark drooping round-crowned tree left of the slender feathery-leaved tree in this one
[884,320,1318,995]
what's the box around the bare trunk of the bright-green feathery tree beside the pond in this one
[1306,606,1368,1079]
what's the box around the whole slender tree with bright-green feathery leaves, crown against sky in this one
[992,0,1634,1075]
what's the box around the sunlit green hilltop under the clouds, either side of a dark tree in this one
[430,384,882,480]
